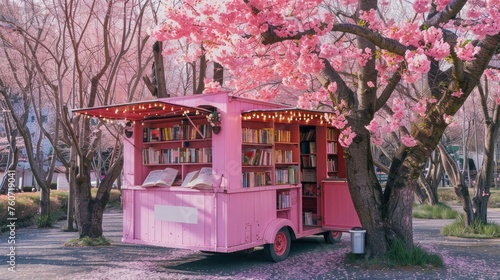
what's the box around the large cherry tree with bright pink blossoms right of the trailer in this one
[151,0,500,255]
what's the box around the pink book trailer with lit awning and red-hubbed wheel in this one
[76,93,359,261]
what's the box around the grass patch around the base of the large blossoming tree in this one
[346,240,444,269]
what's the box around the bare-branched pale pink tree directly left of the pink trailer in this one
[0,0,159,237]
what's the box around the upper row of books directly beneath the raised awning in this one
[143,124,212,143]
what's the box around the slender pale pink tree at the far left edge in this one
[0,3,57,219]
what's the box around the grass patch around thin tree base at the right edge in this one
[441,216,500,239]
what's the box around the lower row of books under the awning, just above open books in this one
[142,147,212,164]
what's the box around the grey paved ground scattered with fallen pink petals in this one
[0,209,500,279]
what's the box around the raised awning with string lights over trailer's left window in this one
[73,100,212,121]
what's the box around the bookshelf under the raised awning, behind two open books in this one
[141,117,213,186]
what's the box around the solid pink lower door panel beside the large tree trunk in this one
[321,180,361,231]
